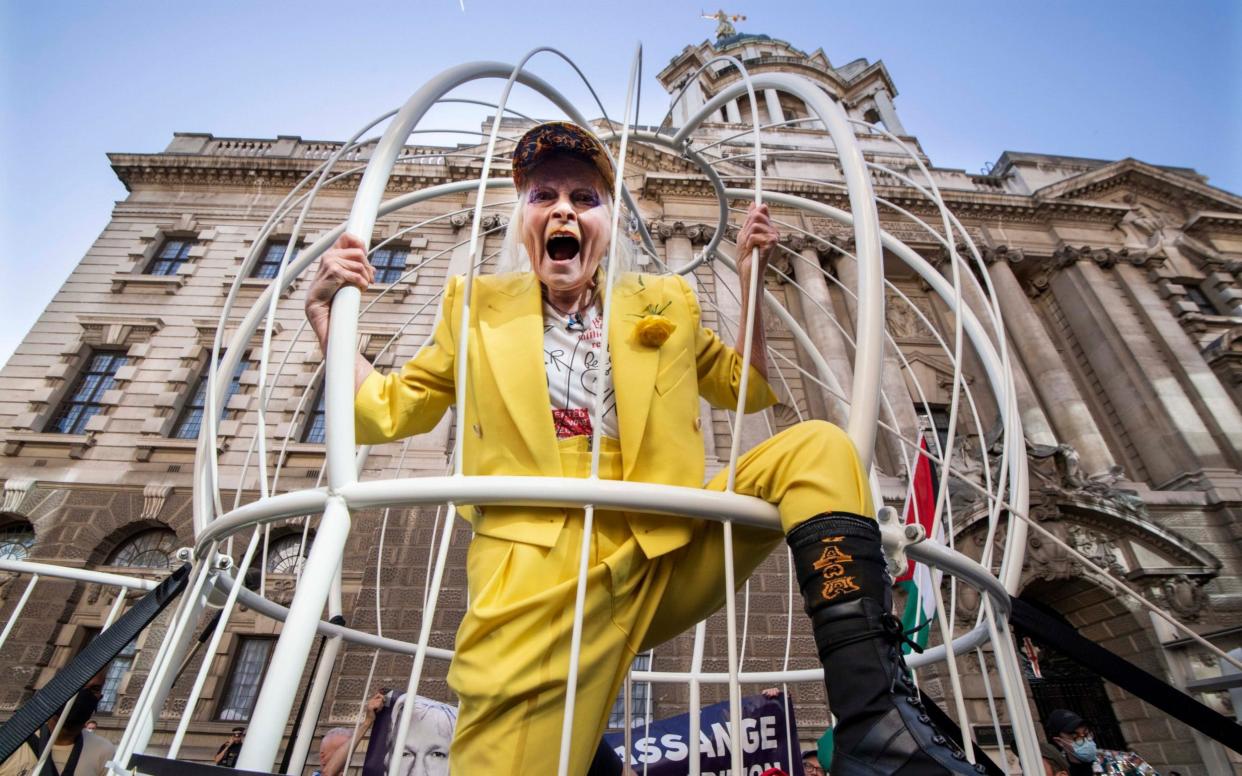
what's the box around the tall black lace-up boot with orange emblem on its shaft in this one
[785,512,985,776]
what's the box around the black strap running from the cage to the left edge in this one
[0,564,190,762]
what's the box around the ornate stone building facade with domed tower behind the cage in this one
[0,28,1242,774]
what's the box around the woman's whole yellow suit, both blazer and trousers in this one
[355,273,871,776]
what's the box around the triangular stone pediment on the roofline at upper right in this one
[1032,159,1242,214]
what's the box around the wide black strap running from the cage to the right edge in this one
[1010,598,1242,752]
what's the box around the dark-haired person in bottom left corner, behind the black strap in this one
[0,677,117,776]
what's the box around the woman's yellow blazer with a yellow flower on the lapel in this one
[354,272,776,557]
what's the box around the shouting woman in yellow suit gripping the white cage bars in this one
[306,122,972,776]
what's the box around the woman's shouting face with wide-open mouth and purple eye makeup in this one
[522,155,612,292]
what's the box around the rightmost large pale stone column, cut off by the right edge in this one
[1115,261,1242,468]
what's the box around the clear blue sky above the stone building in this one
[0,0,1242,363]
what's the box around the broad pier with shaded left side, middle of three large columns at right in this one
[1049,247,1226,489]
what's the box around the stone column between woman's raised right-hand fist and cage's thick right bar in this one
[790,237,853,427]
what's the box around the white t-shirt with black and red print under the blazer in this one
[544,300,620,440]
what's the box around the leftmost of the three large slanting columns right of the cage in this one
[987,251,1117,466]
